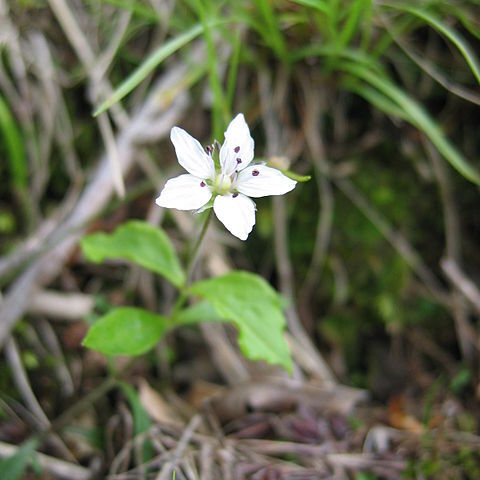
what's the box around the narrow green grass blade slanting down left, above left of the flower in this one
[93,24,203,117]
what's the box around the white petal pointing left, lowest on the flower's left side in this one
[155,173,212,210]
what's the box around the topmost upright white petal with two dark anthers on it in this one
[220,113,255,175]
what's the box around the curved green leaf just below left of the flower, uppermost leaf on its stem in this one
[80,220,185,287]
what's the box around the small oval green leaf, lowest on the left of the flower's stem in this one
[83,307,170,356]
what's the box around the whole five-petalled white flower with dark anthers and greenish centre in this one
[156,113,297,240]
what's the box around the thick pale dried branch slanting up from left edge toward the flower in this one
[0,65,188,347]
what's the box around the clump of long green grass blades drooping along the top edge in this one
[94,0,480,184]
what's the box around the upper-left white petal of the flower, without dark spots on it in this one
[170,127,215,178]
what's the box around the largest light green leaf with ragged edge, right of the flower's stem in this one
[189,272,292,372]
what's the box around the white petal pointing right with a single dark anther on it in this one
[234,165,297,198]
